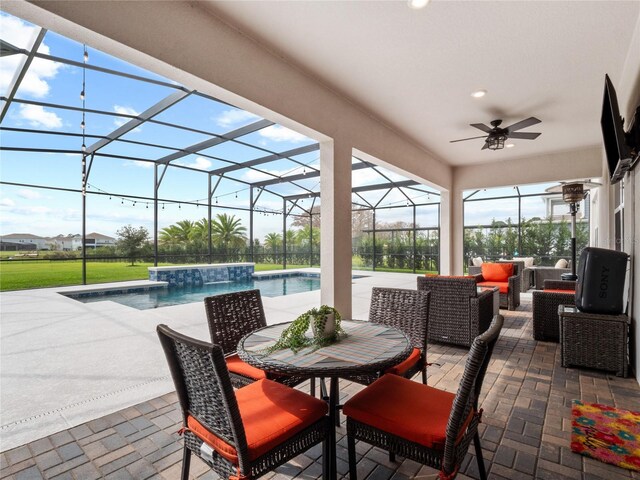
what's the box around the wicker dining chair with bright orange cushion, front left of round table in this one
[157,325,329,480]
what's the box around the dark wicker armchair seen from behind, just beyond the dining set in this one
[418,276,493,347]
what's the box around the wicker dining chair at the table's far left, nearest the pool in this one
[204,289,305,388]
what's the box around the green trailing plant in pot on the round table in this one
[267,305,346,353]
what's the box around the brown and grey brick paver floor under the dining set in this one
[0,304,640,480]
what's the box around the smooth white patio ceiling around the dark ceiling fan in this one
[201,0,640,165]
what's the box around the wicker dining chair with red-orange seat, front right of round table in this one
[344,315,503,480]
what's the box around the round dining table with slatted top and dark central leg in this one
[238,320,412,480]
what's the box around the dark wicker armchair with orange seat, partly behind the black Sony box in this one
[532,280,576,342]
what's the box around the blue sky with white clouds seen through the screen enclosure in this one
[0,12,560,244]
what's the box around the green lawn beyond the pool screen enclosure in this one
[0,260,307,291]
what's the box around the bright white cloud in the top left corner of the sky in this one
[0,15,63,98]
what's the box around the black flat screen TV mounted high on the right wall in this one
[600,75,632,184]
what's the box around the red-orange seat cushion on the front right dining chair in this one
[343,375,474,450]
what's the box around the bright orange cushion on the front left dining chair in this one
[187,379,327,465]
